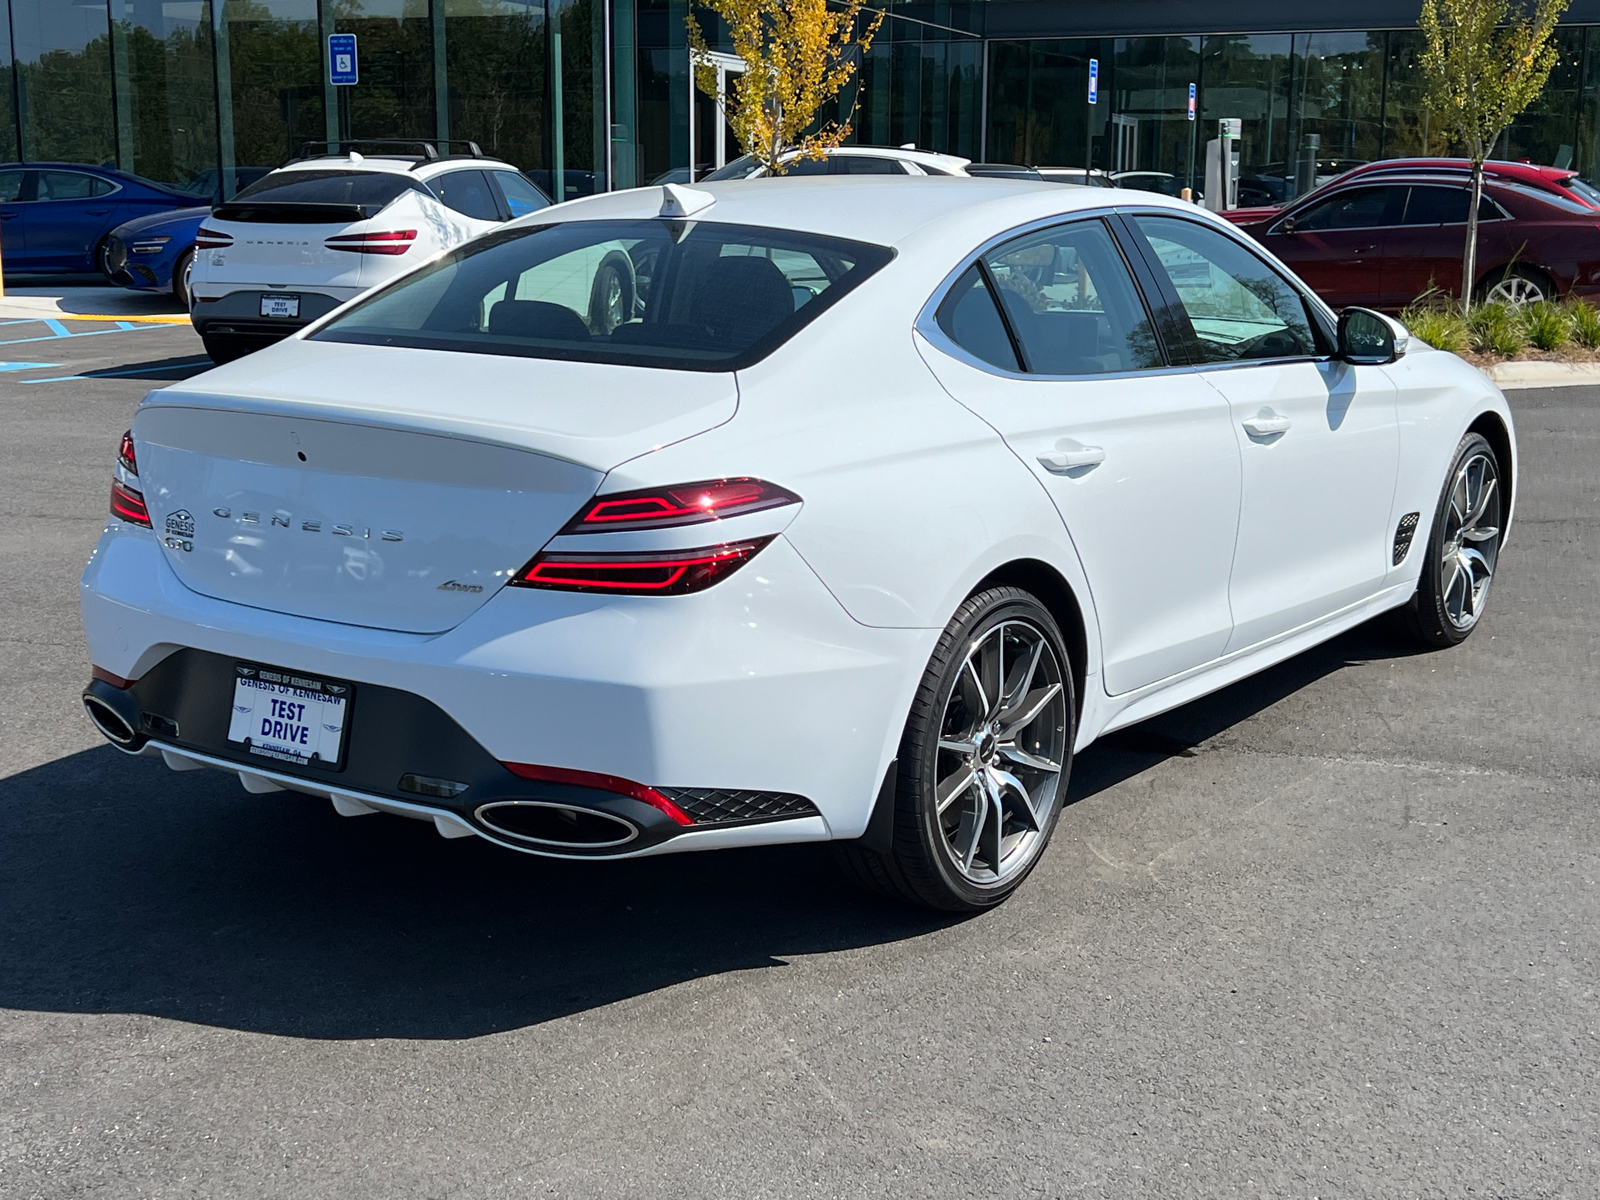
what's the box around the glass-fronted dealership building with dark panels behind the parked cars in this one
[9,0,1600,197]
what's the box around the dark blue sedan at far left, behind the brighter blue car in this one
[0,163,208,274]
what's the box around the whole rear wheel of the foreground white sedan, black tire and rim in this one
[837,587,1077,912]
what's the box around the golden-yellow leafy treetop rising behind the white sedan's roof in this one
[688,0,883,174]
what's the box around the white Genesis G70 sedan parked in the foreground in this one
[83,176,1517,910]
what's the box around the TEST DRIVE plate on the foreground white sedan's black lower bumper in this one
[227,662,350,768]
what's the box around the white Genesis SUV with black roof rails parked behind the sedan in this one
[190,142,550,363]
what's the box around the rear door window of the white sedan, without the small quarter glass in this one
[984,221,1162,374]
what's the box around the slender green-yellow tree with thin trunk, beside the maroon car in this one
[1418,0,1571,309]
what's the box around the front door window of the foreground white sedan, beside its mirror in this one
[1134,216,1317,363]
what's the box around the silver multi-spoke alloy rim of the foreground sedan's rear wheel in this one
[934,621,1069,886]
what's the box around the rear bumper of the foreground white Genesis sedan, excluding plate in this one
[82,523,938,858]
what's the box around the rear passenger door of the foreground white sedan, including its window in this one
[922,219,1240,694]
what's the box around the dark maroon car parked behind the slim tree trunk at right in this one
[1229,168,1600,309]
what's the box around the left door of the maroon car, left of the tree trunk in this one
[1261,184,1406,307]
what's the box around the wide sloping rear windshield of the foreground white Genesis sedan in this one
[312,219,893,371]
